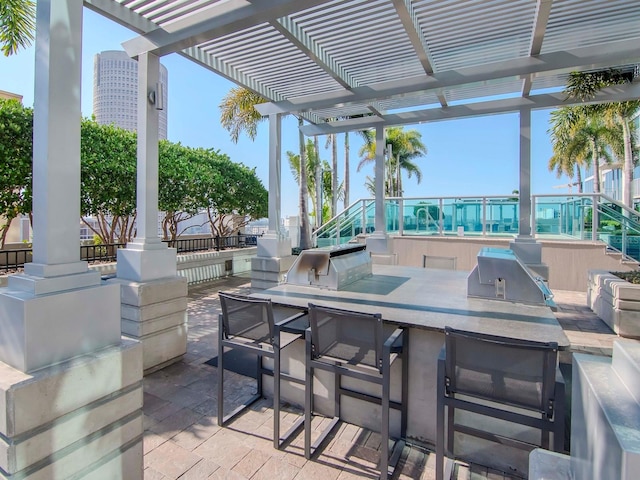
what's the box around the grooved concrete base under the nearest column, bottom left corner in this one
[0,339,143,480]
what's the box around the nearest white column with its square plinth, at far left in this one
[0,0,120,372]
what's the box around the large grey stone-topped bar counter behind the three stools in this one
[253,265,570,469]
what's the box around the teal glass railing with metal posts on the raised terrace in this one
[314,194,640,259]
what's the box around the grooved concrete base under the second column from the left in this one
[107,276,187,375]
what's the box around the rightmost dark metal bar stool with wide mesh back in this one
[436,327,564,480]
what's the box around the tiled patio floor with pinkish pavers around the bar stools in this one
[143,277,616,480]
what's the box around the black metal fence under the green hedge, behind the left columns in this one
[0,235,258,272]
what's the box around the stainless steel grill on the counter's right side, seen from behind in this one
[467,248,556,310]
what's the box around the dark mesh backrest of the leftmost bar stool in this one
[218,292,273,344]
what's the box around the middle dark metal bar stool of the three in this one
[304,304,408,479]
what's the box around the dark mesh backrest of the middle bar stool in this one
[309,304,383,372]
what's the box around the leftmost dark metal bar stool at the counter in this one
[218,292,306,448]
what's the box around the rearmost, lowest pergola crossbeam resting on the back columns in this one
[302,83,640,136]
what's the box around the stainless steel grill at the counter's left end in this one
[286,245,371,290]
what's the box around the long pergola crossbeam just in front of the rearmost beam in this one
[256,41,640,115]
